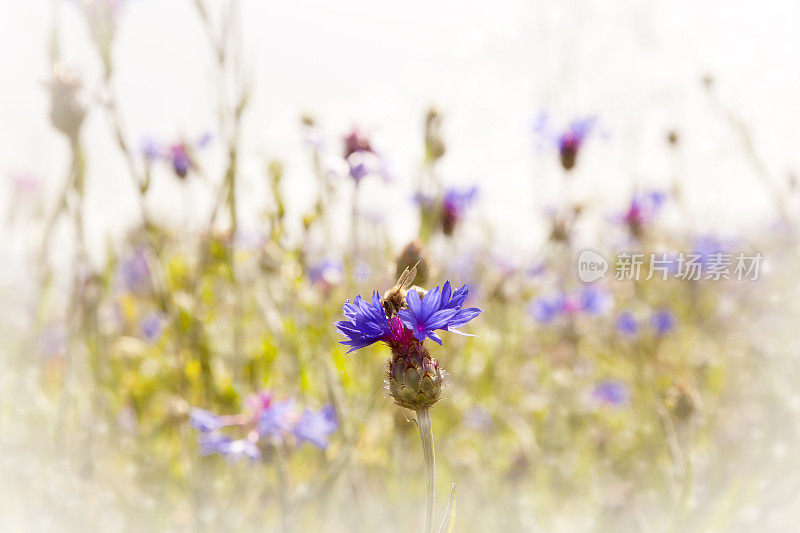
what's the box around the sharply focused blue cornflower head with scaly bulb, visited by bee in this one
[336,272,481,410]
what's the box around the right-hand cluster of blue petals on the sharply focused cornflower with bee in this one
[397,281,481,344]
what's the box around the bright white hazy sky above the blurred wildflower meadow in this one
[0,0,800,262]
